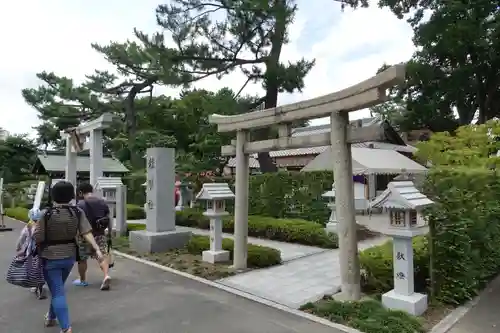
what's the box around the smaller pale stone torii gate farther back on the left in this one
[60,113,114,186]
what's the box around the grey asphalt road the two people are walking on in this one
[0,218,340,333]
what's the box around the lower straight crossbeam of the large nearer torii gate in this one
[221,125,385,156]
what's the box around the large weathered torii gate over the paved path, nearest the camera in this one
[209,64,405,300]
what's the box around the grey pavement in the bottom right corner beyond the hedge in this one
[448,276,500,333]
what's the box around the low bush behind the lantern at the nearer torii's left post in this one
[187,235,281,268]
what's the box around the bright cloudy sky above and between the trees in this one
[0,0,414,137]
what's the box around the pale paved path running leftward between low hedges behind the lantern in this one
[128,220,328,262]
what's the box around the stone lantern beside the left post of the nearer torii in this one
[196,183,234,264]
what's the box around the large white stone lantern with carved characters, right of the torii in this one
[372,181,433,316]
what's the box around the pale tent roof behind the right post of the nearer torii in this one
[301,147,427,175]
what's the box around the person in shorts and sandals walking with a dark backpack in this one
[73,183,111,290]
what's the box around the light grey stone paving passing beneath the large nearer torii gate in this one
[217,237,388,309]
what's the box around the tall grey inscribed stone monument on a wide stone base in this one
[129,148,191,253]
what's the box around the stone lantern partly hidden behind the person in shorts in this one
[95,177,127,236]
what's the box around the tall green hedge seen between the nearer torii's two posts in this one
[249,171,333,224]
